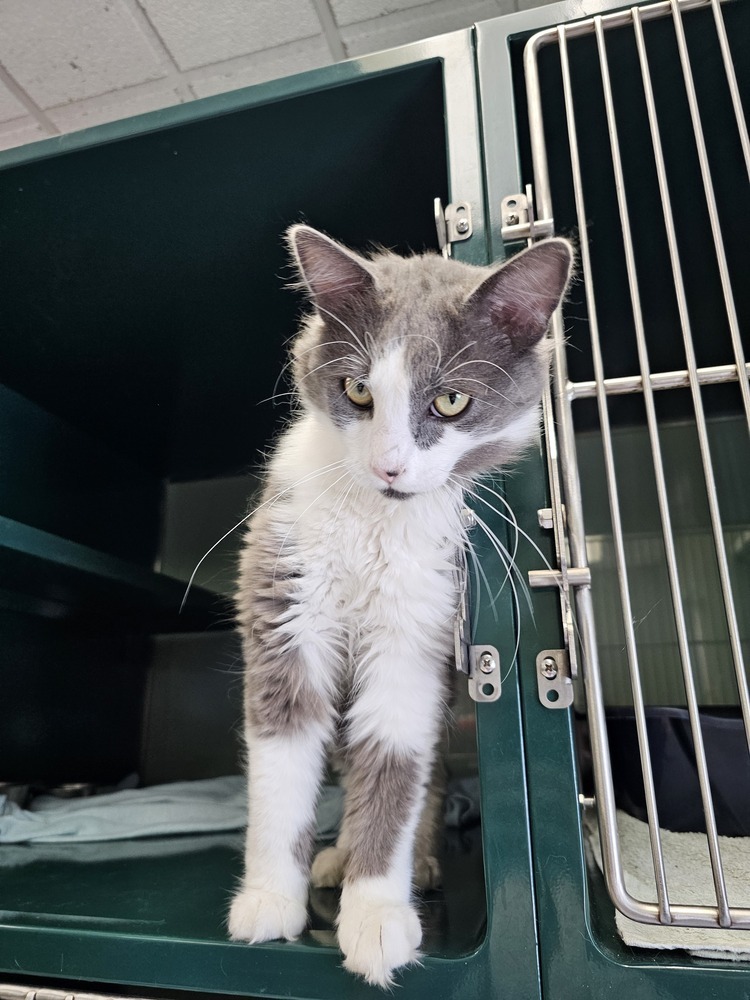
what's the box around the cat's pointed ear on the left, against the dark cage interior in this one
[286,225,374,317]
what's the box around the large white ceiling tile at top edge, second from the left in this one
[139,0,320,70]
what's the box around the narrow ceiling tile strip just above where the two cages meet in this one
[341,0,499,56]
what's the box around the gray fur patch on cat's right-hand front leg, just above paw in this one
[344,742,419,880]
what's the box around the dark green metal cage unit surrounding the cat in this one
[0,0,750,1000]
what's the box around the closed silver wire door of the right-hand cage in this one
[524,0,750,928]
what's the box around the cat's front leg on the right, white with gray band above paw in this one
[338,640,445,987]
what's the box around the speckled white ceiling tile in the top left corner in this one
[0,0,164,108]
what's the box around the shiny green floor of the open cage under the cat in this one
[0,827,486,972]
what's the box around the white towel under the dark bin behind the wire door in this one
[586,810,750,961]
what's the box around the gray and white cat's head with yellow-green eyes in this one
[287,225,572,499]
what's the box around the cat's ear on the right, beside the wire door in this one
[466,239,573,351]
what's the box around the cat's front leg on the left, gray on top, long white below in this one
[229,648,333,943]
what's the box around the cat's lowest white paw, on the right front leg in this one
[339,901,422,989]
